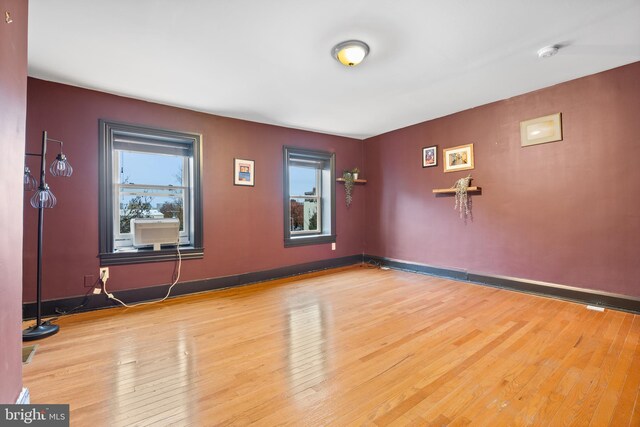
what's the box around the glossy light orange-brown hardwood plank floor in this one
[24,267,640,427]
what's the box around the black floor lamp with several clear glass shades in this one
[22,131,73,341]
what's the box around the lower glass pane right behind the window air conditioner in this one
[120,194,184,234]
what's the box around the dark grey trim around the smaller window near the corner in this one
[282,145,336,248]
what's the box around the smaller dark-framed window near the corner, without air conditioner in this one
[284,147,336,247]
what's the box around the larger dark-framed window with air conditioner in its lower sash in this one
[99,120,202,265]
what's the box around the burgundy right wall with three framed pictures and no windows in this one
[364,63,640,297]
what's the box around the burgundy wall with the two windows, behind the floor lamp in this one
[24,78,365,302]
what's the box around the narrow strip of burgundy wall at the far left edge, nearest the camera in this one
[0,0,28,403]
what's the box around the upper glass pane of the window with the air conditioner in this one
[117,150,185,186]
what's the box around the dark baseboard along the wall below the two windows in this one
[22,254,362,320]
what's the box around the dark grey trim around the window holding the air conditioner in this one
[98,119,204,265]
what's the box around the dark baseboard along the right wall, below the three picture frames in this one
[364,254,640,314]
